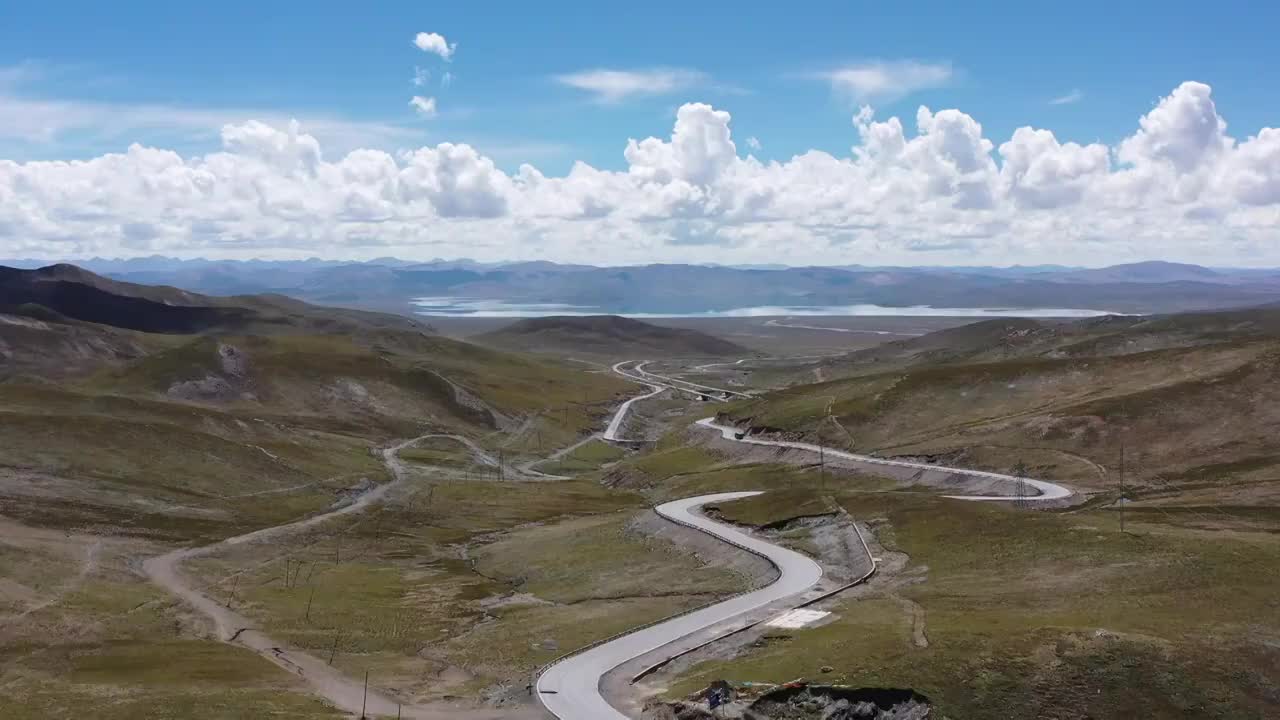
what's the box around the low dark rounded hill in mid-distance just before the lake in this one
[475,315,751,357]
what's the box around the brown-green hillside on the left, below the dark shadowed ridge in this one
[0,268,630,539]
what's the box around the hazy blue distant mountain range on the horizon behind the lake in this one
[0,256,1280,314]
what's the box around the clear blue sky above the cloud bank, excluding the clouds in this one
[10,1,1280,173]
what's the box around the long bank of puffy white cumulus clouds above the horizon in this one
[0,82,1280,264]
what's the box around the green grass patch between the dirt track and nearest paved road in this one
[188,471,748,701]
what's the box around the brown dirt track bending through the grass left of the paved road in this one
[142,436,540,720]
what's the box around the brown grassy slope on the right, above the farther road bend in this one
[728,311,1280,505]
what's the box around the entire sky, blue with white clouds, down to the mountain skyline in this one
[0,0,1280,265]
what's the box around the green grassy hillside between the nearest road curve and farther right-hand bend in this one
[609,420,1280,720]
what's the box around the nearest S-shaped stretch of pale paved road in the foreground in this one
[536,492,822,720]
